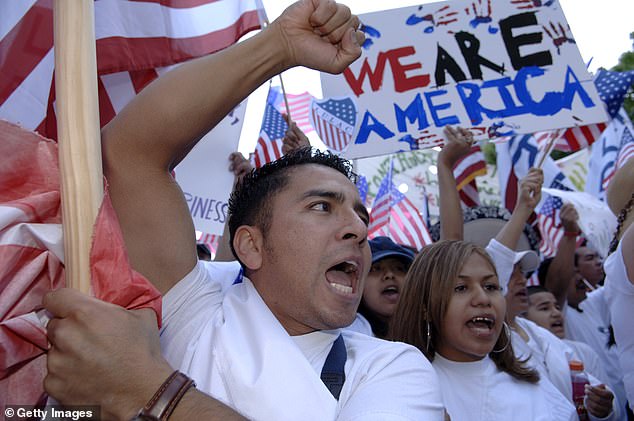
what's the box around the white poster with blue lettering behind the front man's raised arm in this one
[175,101,247,235]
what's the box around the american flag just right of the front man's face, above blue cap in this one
[368,163,432,250]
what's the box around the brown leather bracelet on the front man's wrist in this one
[132,371,196,421]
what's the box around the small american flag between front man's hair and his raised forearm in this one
[252,91,288,168]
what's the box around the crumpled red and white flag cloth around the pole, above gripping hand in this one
[0,120,161,406]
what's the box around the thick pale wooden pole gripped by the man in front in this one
[53,0,103,292]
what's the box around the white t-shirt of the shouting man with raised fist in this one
[161,262,444,421]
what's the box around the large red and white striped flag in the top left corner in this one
[0,0,263,139]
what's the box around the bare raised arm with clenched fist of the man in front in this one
[102,0,363,293]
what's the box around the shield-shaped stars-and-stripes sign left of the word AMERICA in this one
[310,98,357,152]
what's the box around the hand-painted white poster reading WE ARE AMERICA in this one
[321,0,607,158]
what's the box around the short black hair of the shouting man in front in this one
[228,147,356,266]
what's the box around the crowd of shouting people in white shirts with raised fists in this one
[43,0,634,421]
